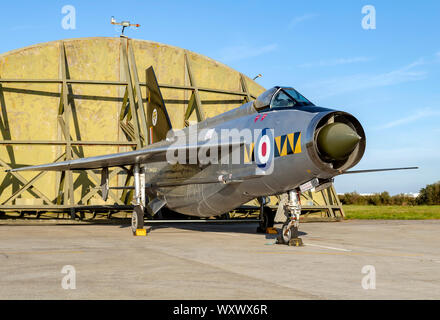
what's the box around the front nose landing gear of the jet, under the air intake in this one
[277,190,303,247]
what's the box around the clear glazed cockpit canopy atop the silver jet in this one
[254,87,314,111]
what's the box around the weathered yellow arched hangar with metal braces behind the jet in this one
[0,37,343,216]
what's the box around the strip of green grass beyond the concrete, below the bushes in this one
[343,205,440,220]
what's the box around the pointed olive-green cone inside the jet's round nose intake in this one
[317,122,362,160]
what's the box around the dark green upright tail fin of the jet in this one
[145,67,172,144]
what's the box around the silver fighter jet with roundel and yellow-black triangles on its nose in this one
[8,67,415,243]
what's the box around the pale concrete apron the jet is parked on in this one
[0,221,440,300]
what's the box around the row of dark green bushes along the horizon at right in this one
[339,181,440,206]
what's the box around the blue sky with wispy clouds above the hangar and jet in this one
[0,0,440,194]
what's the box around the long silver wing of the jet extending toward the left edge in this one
[7,141,243,172]
